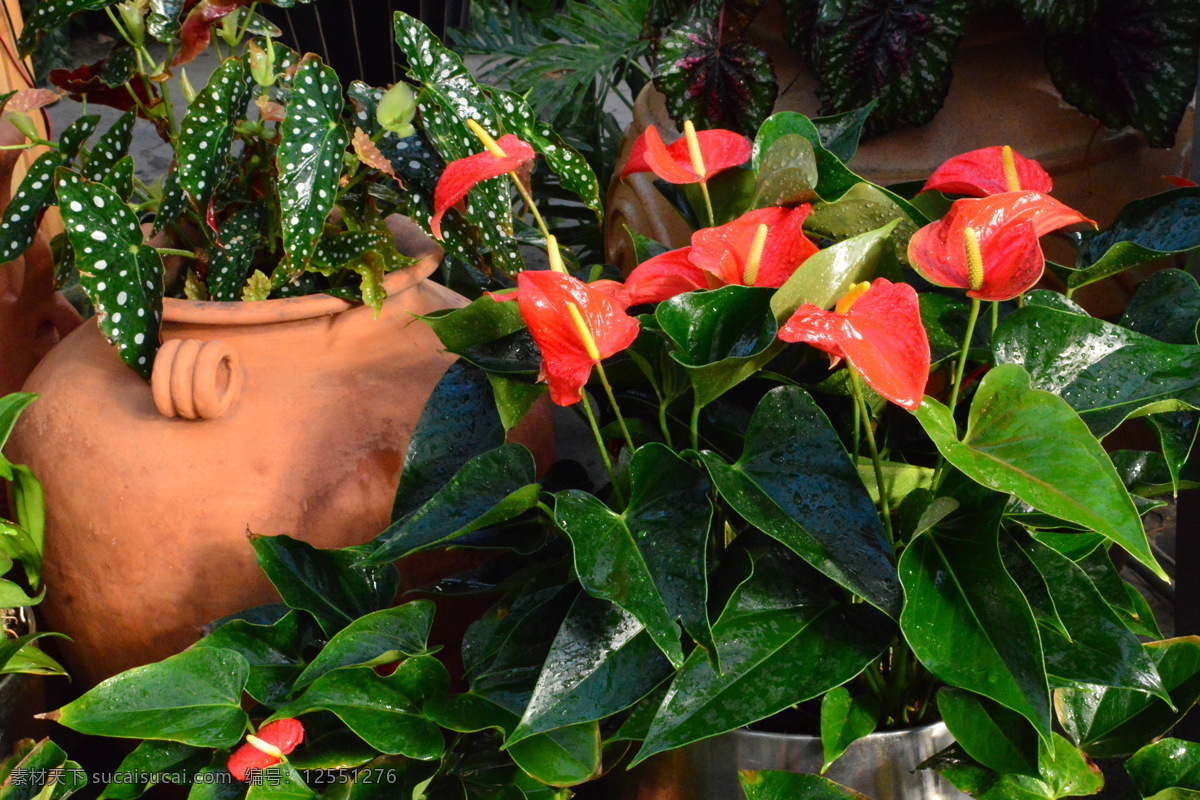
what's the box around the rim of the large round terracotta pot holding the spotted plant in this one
[162,231,442,325]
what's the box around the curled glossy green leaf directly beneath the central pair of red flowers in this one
[654,285,782,405]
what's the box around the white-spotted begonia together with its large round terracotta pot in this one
[0,0,580,682]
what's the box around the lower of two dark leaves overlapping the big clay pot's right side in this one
[370,443,541,564]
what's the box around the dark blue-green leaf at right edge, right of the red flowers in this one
[1067,187,1200,289]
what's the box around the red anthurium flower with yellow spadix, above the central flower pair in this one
[620,120,754,184]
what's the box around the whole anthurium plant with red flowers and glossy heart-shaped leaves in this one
[7,16,1200,800]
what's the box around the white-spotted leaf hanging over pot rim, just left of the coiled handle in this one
[55,169,162,378]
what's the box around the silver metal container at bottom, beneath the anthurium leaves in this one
[630,722,967,800]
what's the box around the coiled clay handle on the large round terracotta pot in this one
[150,339,242,420]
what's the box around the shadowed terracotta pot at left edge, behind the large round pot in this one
[0,120,80,398]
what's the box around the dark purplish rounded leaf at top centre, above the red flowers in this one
[654,0,776,136]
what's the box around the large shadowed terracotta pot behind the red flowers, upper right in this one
[605,7,1194,315]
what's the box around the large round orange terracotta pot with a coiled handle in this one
[12,227,477,686]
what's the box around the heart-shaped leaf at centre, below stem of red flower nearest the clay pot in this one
[554,443,713,666]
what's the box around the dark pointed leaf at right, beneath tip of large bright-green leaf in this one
[1021,540,1166,698]
